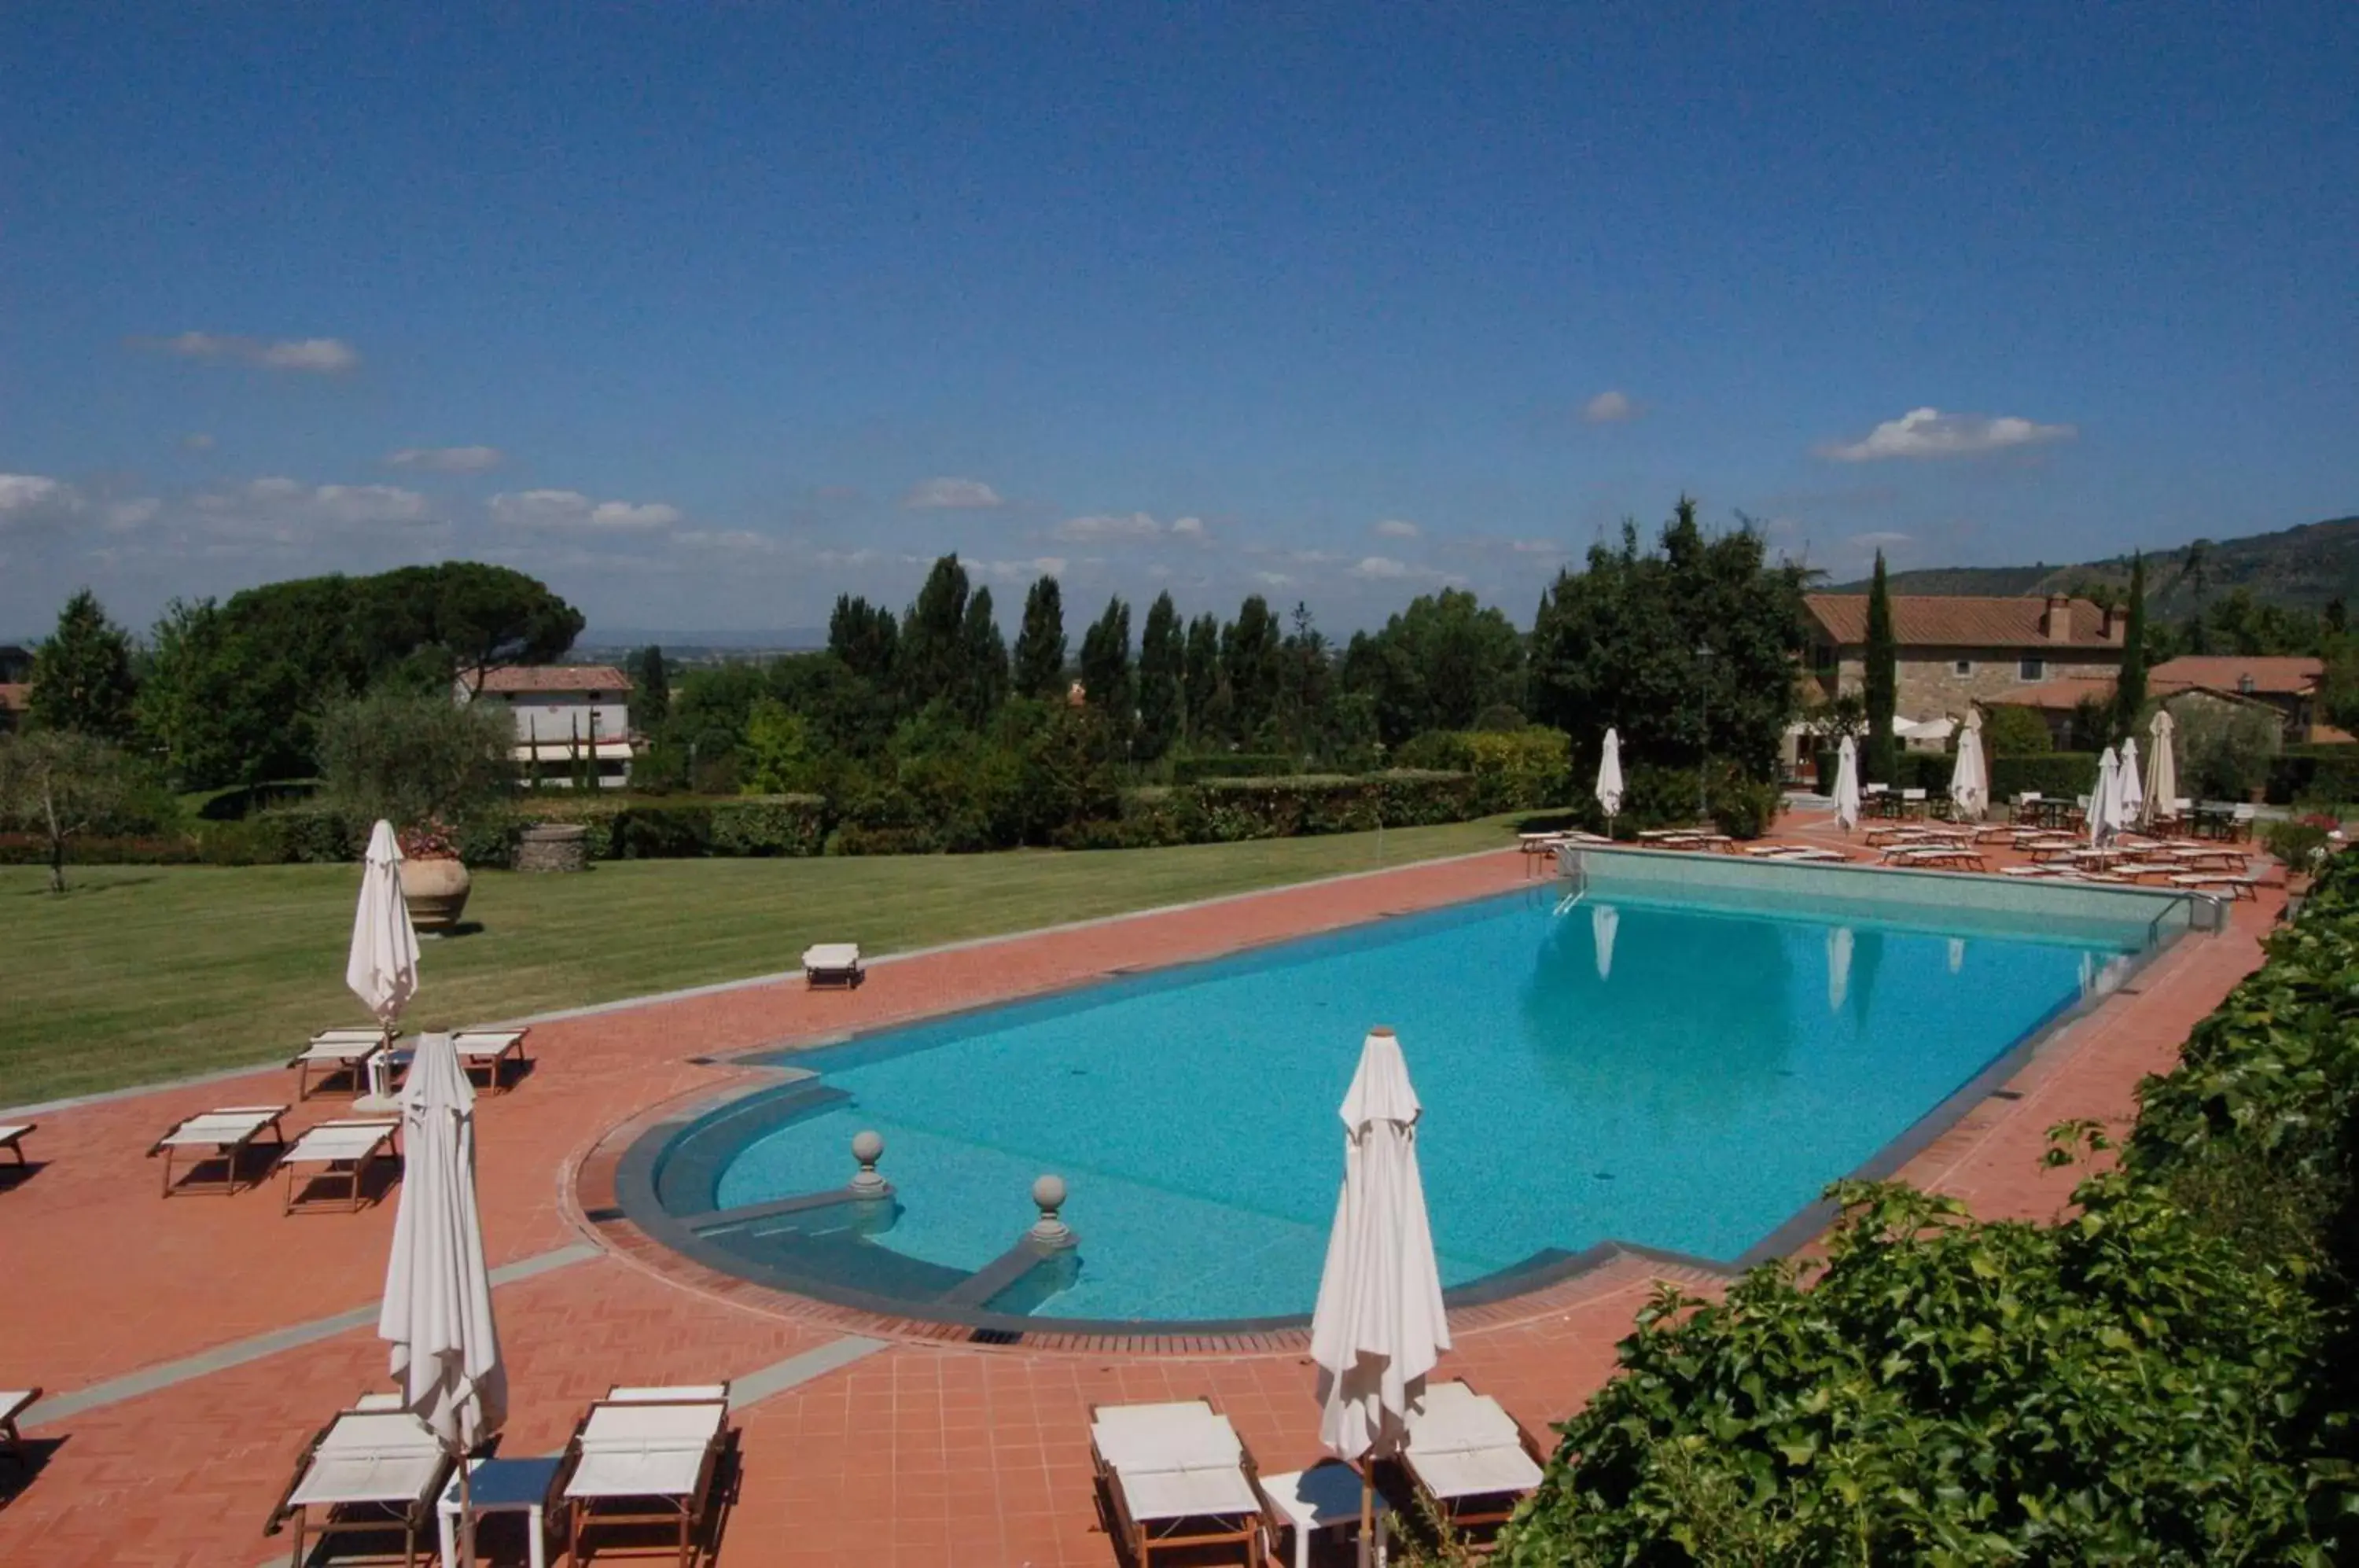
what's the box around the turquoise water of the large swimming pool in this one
[715,893,2147,1320]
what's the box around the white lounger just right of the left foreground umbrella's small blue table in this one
[557,1384,729,1568]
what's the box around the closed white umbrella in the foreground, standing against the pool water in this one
[1312,1028,1451,1561]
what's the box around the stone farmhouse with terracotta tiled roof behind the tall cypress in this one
[1802,594,2128,724]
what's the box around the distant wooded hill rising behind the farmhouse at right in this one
[1828,517,2359,616]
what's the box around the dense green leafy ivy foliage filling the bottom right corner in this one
[1500,858,2359,1568]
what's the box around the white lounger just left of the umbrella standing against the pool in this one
[1090,1398,1276,1568]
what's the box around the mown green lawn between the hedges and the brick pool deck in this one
[0,818,1510,1106]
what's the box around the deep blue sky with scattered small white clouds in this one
[0,0,2359,632]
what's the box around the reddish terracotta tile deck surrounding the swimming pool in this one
[0,818,2284,1568]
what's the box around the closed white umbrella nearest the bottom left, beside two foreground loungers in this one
[377,1032,507,1518]
